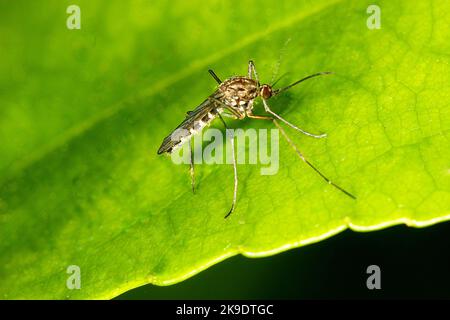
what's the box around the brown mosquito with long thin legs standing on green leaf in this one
[158,60,356,218]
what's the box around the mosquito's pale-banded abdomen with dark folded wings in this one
[158,98,218,154]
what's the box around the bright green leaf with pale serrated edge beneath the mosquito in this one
[0,0,450,298]
